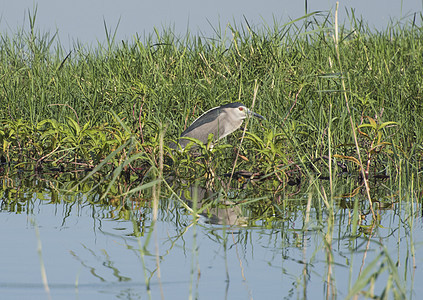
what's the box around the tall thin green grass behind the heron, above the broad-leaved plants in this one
[0,10,423,134]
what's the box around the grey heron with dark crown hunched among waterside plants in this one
[174,102,264,149]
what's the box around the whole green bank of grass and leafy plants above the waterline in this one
[0,10,423,195]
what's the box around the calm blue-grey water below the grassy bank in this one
[0,184,423,299]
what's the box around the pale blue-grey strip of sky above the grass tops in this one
[0,0,423,46]
